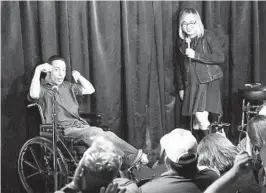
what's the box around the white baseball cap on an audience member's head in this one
[160,128,198,164]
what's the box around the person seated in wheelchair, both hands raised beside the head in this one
[28,55,148,170]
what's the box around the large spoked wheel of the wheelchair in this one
[18,137,68,193]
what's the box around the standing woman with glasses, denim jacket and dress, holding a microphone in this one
[177,8,225,140]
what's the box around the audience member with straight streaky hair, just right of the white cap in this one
[198,133,259,193]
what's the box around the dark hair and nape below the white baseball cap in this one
[166,154,198,179]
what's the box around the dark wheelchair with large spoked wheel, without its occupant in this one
[18,103,109,193]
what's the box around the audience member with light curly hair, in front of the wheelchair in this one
[57,137,122,193]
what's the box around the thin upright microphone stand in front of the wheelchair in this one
[52,88,58,191]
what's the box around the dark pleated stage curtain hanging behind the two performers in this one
[1,1,266,192]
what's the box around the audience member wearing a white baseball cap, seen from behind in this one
[140,129,218,193]
